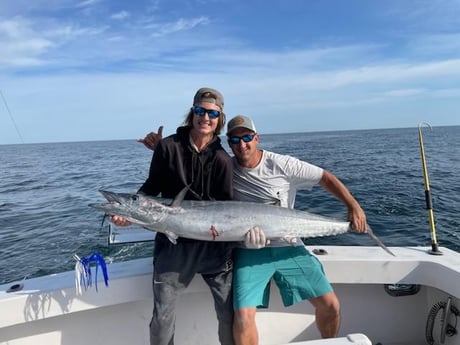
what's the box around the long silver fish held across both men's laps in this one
[90,188,394,255]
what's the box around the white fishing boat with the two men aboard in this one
[0,125,460,345]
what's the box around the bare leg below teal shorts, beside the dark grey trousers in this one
[233,308,259,345]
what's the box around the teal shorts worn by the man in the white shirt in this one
[233,246,333,309]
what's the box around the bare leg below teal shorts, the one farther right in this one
[310,292,340,338]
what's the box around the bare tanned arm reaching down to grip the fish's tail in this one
[319,170,367,232]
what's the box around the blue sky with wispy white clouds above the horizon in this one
[0,0,460,144]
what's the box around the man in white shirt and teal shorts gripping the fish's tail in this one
[227,115,366,345]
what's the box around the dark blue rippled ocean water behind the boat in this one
[0,126,460,284]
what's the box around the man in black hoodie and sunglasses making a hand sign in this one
[111,88,234,345]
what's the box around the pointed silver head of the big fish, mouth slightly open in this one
[89,190,168,226]
